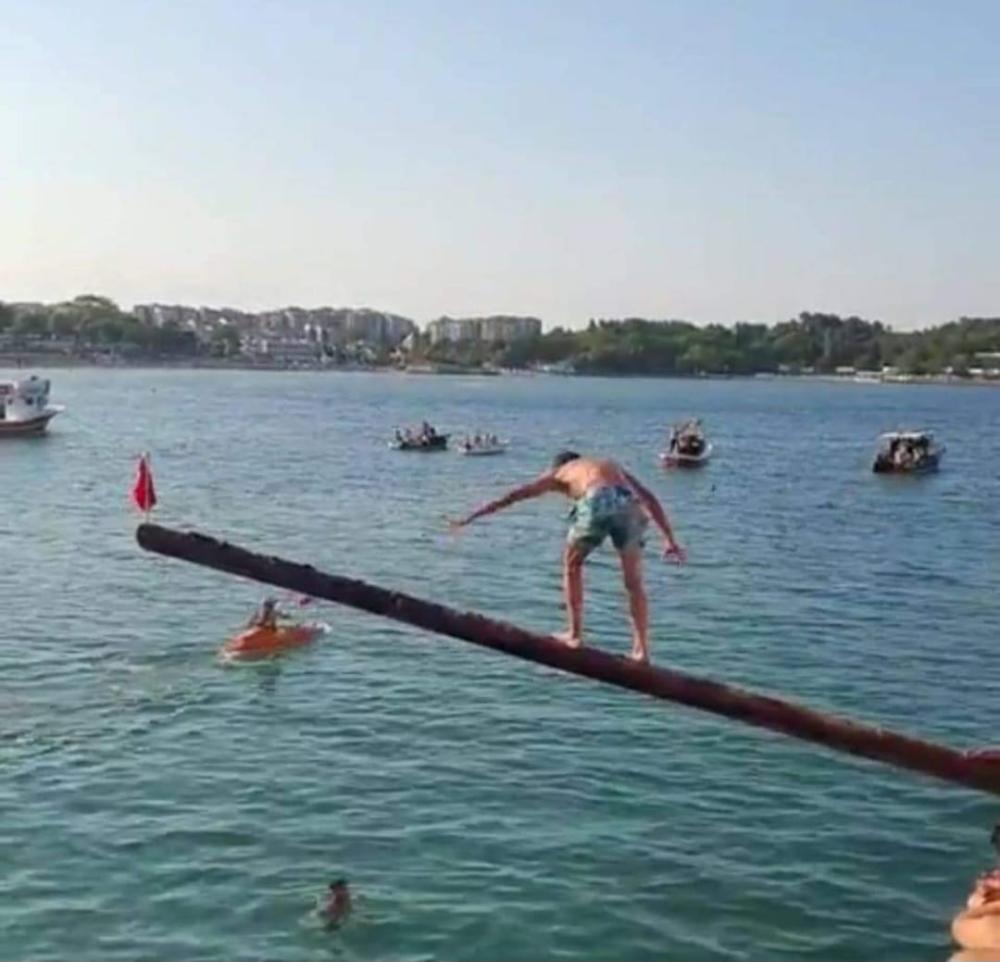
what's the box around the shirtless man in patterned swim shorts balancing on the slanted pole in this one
[449,451,684,662]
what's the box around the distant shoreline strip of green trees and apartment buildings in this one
[0,294,1000,383]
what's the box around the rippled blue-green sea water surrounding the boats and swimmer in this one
[0,371,1000,960]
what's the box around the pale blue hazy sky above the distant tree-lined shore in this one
[0,0,1000,328]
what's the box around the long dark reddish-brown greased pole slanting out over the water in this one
[136,524,1000,795]
